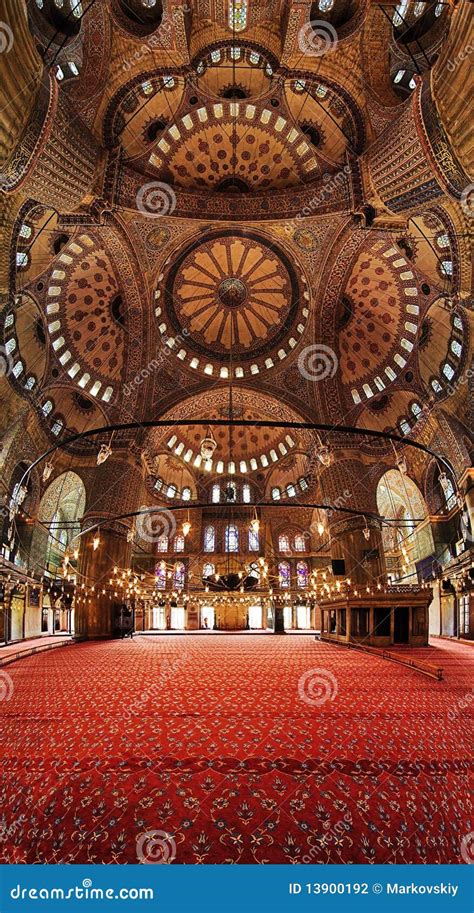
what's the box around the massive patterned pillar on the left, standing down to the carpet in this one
[75,460,142,638]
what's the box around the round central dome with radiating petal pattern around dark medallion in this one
[160,231,303,362]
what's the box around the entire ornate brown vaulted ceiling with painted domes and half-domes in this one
[0,0,472,624]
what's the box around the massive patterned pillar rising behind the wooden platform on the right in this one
[321,459,386,585]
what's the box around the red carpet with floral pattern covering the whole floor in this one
[0,635,474,864]
